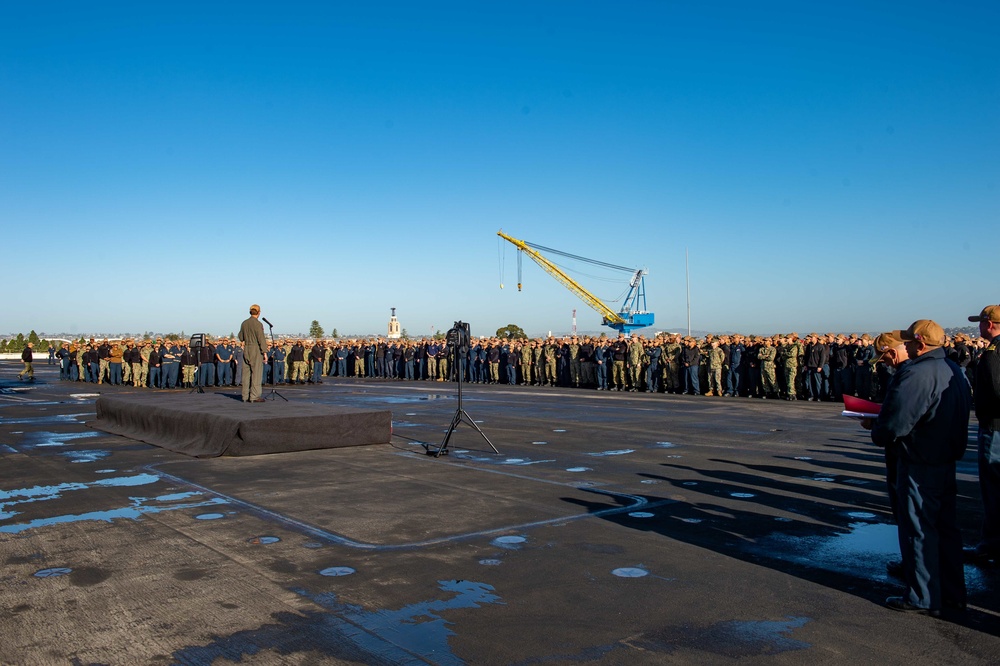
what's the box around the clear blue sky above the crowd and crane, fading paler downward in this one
[0,0,1000,335]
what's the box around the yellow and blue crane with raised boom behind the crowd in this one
[497,230,655,333]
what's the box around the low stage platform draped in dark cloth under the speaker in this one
[87,393,392,458]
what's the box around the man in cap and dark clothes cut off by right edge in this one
[966,305,1000,561]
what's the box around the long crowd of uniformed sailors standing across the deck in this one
[48,333,986,401]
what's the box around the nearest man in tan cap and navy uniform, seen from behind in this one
[862,319,972,617]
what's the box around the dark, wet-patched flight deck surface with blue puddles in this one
[0,362,1000,664]
